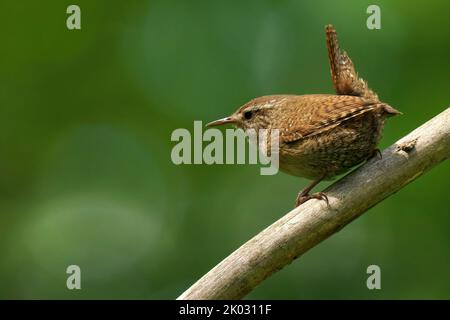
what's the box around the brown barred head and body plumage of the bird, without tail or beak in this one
[236,94,400,179]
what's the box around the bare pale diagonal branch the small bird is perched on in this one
[178,108,450,299]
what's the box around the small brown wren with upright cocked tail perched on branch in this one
[207,25,401,206]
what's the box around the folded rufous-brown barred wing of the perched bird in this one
[280,95,382,143]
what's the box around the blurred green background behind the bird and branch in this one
[0,0,450,299]
